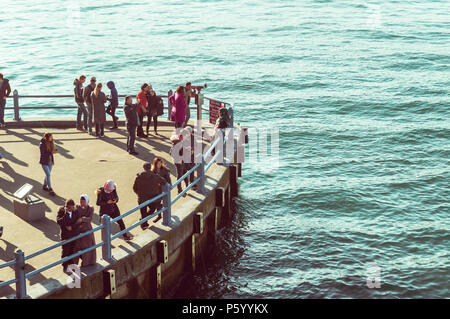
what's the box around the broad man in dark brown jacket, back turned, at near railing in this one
[133,163,167,229]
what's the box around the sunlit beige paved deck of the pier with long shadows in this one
[0,121,214,297]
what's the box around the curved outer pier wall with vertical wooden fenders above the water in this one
[29,162,236,299]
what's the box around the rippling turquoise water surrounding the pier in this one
[0,0,450,298]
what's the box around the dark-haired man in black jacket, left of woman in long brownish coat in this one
[57,199,82,272]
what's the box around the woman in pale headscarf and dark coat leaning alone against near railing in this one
[95,180,133,240]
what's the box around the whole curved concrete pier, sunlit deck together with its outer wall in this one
[0,119,237,299]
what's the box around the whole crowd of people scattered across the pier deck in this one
[0,74,231,271]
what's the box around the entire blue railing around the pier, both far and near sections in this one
[0,91,237,298]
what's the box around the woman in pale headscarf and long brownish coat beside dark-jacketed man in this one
[75,194,97,267]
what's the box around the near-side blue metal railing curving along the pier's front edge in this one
[0,120,233,299]
